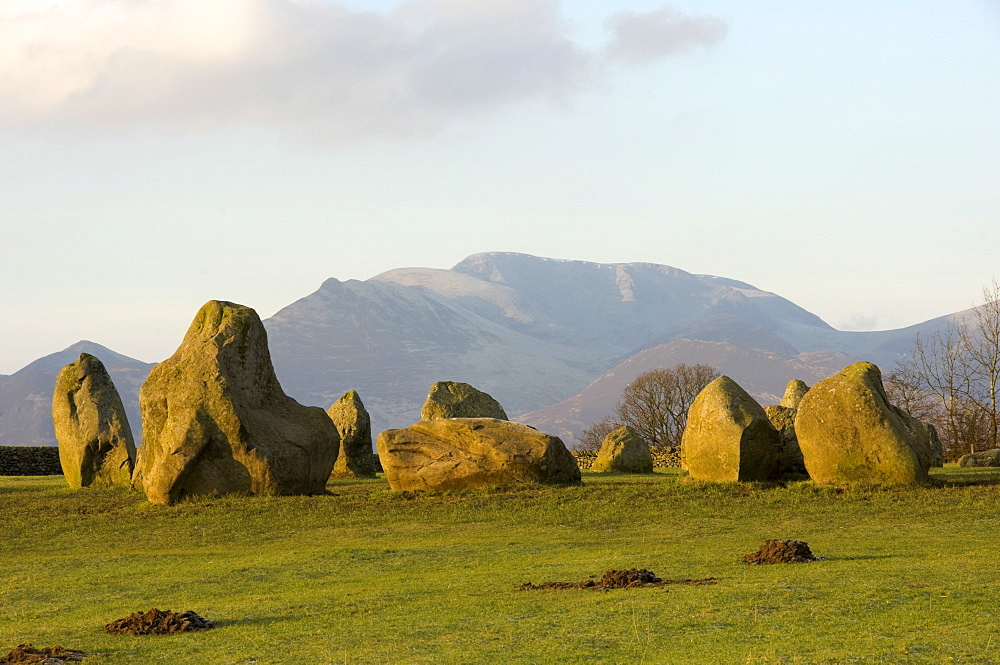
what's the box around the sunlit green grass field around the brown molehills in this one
[0,467,1000,664]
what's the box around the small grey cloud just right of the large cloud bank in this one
[607,5,728,63]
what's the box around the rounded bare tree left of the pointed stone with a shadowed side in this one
[612,363,719,446]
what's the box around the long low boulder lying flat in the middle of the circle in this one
[376,418,580,491]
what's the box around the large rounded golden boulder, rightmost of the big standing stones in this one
[795,362,932,485]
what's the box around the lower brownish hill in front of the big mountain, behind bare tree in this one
[517,339,858,445]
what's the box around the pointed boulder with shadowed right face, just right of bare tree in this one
[681,376,780,482]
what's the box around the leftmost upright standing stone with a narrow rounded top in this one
[52,353,135,487]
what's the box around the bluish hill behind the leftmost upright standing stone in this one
[0,340,153,446]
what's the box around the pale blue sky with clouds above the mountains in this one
[0,0,1000,374]
